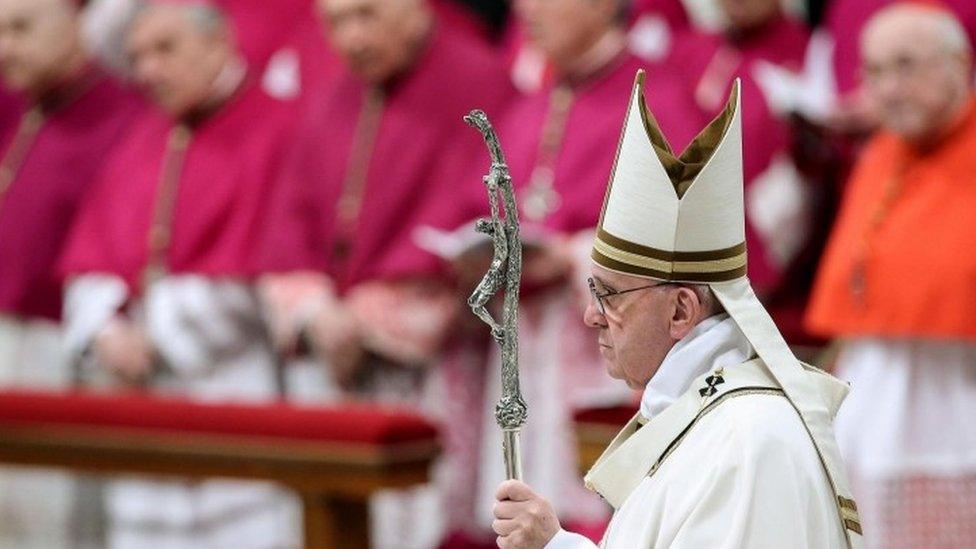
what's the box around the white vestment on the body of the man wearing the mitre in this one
[546,315,847,549]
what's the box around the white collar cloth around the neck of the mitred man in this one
[640,313,756,420]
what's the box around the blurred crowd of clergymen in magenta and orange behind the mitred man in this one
[0,0,976,549]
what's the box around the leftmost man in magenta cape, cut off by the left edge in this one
[0,0,137,547]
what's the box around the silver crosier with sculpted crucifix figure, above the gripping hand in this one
[464,110,528,479]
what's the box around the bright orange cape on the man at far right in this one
[806,98,976,339]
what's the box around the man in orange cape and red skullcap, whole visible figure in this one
[807,3,976,547]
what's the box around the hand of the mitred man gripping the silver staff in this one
[491,480,560,549]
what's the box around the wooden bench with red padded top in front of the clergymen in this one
[0,392,439,549]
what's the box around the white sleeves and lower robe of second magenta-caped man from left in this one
[65,275,300,549]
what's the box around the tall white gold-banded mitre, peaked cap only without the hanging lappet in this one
[592,71,747,283]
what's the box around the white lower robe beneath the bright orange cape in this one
[836,338,976,547]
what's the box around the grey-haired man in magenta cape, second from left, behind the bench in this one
[63,0,298,548]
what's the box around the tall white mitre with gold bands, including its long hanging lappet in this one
[592,71,860,546]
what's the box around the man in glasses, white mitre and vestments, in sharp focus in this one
[493,73,861,549]
